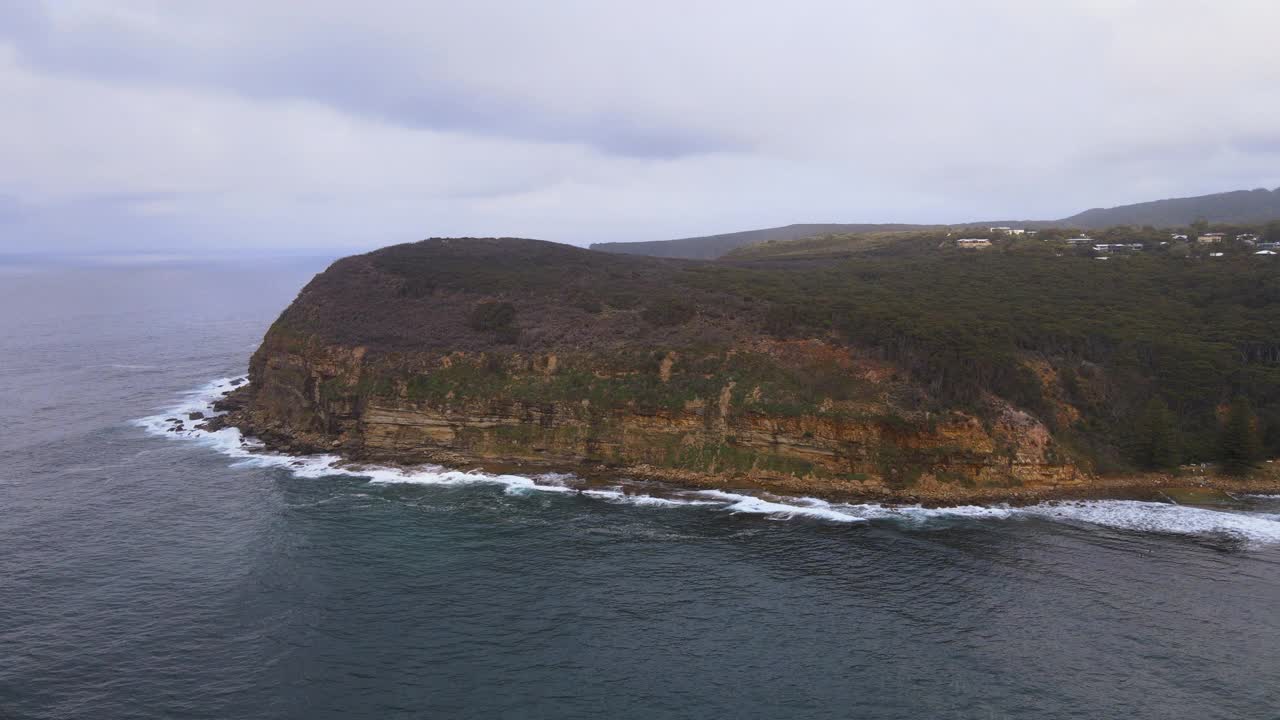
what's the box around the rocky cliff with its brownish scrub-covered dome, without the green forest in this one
[222,240,1121,496]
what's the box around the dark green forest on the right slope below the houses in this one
[704,249,1280,462]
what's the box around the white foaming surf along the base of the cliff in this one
[136,377,1280,544]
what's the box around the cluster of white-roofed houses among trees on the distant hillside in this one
[947,222,1280,260]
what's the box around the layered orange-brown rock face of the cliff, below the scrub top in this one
[225,319,1085,496]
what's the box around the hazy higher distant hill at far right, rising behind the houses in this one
[1061,188,1280,228]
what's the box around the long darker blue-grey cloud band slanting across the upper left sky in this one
[0,3,748,159]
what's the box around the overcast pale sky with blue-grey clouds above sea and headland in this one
[0,0,1280,254]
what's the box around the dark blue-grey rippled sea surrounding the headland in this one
[0,261,1280,719]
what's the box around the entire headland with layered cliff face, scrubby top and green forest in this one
[230,231,1280,501]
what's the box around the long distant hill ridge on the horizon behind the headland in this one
[591,188,1280,260]
